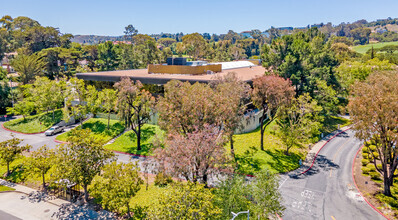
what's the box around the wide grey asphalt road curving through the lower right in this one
[280,130,384,220]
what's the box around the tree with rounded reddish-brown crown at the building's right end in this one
[252,75,294,150]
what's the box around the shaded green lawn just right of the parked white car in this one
[56,118,124,144]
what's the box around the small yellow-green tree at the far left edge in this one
[0,135,32,177]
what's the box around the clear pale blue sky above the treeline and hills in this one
[0,0,398,36]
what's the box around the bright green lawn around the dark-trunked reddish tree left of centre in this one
[104,124,164,155]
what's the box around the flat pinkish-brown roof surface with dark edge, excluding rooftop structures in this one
[76,66,265,84]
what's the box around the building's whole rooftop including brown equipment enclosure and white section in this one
[76,58,265,85]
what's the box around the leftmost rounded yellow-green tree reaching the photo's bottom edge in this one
[90,162,144,219]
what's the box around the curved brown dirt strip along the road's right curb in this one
[354,148,398,219]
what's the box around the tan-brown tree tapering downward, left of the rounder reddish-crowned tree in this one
[211,72,250,155]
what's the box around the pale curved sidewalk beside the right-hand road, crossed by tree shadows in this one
[289,125,351,176]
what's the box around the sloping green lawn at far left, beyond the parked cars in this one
[3,110,62,133]
